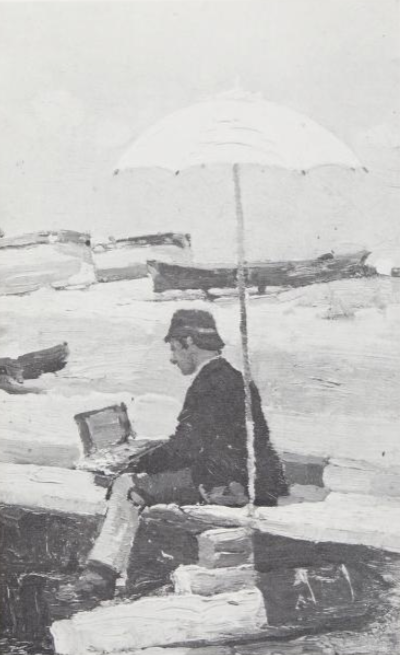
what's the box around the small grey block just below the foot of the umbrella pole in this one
[198,528,253,569]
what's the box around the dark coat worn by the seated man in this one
[135,357,287,505]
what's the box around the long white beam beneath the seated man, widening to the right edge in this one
[148,493,400,553]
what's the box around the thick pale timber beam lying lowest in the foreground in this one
[51,589,266,655]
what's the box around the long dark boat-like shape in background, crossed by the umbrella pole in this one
[148,250,376,293]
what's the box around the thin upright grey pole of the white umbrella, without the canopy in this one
[233,164,256,514]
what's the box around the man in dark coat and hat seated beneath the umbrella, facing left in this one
[59,310,287,600]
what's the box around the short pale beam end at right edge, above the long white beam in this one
[323,460,400,497]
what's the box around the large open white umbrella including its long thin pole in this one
[115,93,361,509]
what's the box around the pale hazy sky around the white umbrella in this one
[0,0,400,258]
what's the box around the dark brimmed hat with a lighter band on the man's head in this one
[164,309,225,350]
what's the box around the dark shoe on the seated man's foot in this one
[55,562,118,611]
